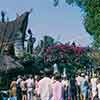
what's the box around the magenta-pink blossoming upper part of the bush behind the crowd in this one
[44,44,86,62]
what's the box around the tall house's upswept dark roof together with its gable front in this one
[0,10,32,54]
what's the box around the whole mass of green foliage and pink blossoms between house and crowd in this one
[15,36,92,75]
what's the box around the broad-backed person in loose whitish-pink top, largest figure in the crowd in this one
[38,69,52,100]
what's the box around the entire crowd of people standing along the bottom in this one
[7,70,100,100]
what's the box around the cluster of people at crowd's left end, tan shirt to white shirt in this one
[9,75,34,100]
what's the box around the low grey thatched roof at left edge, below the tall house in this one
[0,55,24,74]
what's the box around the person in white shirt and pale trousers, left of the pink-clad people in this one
[26,75,34,100]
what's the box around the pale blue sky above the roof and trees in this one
[0,0,91,46]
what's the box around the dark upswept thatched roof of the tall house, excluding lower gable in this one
[0,12,30,46]
